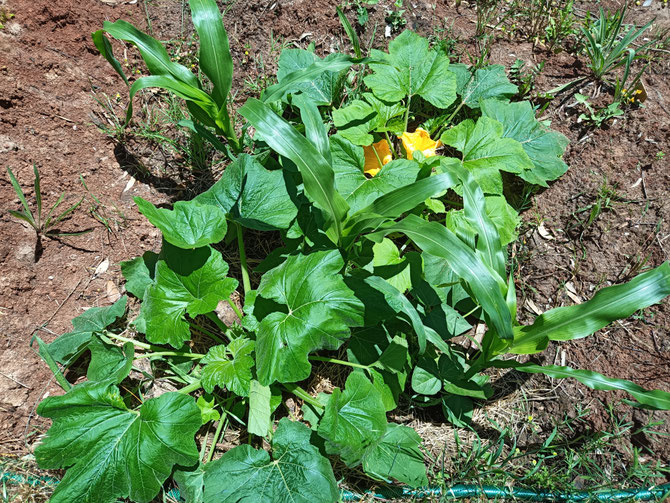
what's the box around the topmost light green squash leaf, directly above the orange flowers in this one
[364,30,456,108]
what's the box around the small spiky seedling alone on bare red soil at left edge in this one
[7,164,89,261]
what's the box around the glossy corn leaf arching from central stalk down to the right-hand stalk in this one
[368,215,513,339]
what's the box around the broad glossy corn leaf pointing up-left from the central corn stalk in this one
[239,98,349,241]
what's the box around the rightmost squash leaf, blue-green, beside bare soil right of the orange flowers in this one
[481,99,568,187]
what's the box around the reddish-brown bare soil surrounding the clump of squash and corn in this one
[0,0,670,492]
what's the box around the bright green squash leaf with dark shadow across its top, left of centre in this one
[142,245,237,348]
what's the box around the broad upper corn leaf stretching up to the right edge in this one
[499,262,670,354]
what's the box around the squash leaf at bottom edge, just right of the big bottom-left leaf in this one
[204,418,339,503]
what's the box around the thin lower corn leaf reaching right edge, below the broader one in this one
[492,360,670,410]
